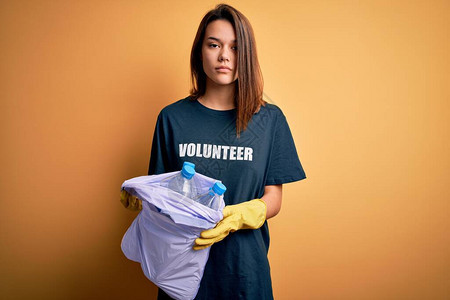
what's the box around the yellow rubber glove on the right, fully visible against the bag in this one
[193,199,267,250]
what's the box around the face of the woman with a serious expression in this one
[202,20,237,85]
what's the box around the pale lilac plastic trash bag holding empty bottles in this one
[121,171,225,300]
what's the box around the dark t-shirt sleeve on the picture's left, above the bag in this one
[148,113,169,175]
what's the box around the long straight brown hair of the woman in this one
[190,4,265,137]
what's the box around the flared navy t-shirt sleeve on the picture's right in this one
[266,111,306,185]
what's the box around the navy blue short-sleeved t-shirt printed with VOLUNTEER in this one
[148,97,306,300]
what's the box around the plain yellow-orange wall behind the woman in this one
[0,0,450,299]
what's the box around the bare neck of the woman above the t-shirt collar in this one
[198,78,235,110]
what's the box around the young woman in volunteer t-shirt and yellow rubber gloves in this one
[124,4,306,300]
